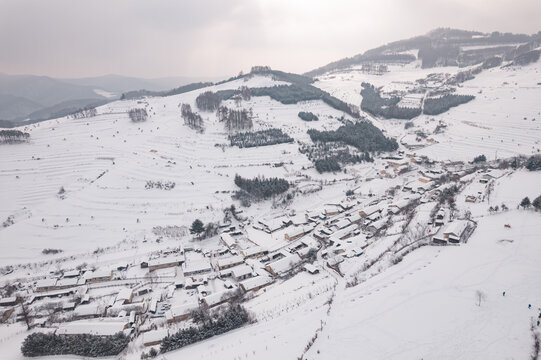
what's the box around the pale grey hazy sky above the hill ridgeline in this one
[0,0,541,77]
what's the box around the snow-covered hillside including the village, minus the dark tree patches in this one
[0,52,541,359]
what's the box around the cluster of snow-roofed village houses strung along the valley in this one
[0,155,502,345]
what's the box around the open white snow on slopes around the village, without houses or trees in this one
[0,62,541,360]
